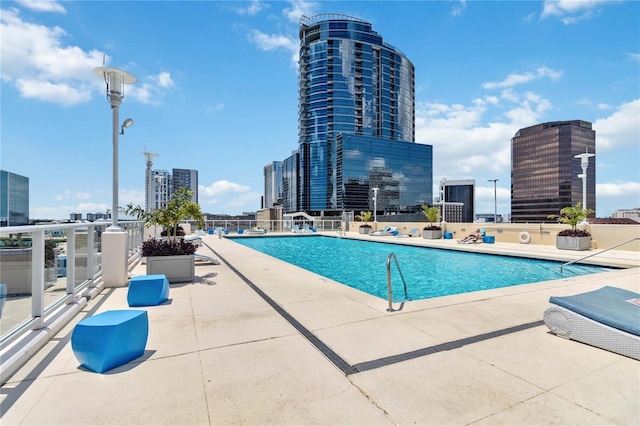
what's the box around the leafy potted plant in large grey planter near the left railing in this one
[132,188,204,283]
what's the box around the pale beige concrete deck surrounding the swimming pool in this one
[0,233,640,426]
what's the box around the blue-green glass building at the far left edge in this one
[0,170,29,226]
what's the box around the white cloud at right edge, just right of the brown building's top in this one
[593,99,640,150]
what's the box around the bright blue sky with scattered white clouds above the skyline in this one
[0,0,640,219]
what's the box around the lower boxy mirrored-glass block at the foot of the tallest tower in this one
[336,134,433,213]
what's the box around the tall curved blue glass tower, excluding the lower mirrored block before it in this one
[298,14,432,211]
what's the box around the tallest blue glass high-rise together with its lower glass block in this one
[298,14,433,212]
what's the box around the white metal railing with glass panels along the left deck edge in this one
[0,222,144,350]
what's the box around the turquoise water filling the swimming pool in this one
[229,236,605,302]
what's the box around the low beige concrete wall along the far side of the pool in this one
[349,222,640,251]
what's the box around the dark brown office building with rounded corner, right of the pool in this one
[511,120,596,223]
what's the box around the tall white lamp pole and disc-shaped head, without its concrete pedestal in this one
[93,67,136,232]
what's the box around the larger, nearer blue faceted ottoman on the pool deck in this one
[71,309,149,373]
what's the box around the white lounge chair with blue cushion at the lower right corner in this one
[543,286,640,360]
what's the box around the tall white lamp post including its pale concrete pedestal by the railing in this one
[93,67,136,287]
